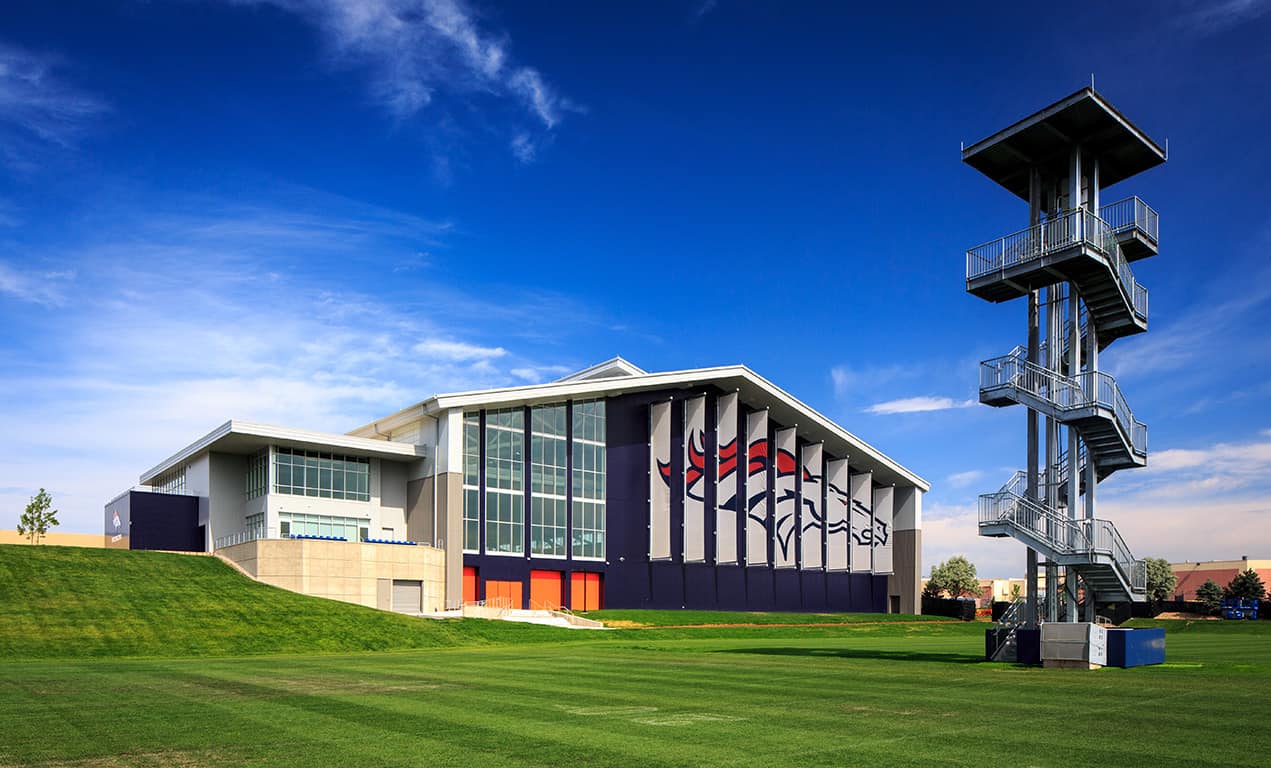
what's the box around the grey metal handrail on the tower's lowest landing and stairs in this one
[979,485,1146,591]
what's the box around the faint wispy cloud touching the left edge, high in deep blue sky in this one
[0,43,107,170]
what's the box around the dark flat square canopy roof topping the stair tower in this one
[962,88,1166,200]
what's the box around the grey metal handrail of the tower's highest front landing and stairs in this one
[966,207,1148,319]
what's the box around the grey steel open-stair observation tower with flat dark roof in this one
[962,88,1166,635]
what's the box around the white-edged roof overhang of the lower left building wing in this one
[141,421,423,484]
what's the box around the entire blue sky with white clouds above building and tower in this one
[0,0,1271,576]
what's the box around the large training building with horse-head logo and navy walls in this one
[105,359,929,613]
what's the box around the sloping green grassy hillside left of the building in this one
[0,544,567,660]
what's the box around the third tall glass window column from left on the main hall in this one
[530,406,568,557]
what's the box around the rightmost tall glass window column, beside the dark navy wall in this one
[571,401,605,559]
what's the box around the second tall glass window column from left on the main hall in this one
[486,408,525,554]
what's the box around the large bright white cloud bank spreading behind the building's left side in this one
[0,188,602,530]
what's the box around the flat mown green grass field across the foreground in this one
[0,548,1271,767]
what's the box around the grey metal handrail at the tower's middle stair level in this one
[980,346,1148,456]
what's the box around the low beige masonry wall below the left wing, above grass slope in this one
[216,539,447,612]
